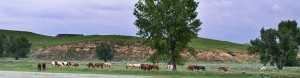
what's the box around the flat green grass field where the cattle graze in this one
[0,59,300,78]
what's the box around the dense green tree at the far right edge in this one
[248,20,300,69]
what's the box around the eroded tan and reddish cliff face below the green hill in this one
[34,41,258,62]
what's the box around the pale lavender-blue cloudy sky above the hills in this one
[0,0,300,44]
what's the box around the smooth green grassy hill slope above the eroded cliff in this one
[0,30,247,52]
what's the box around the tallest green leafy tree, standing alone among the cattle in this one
[134,0,201,71]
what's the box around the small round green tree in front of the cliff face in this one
[96,44,116,62]
